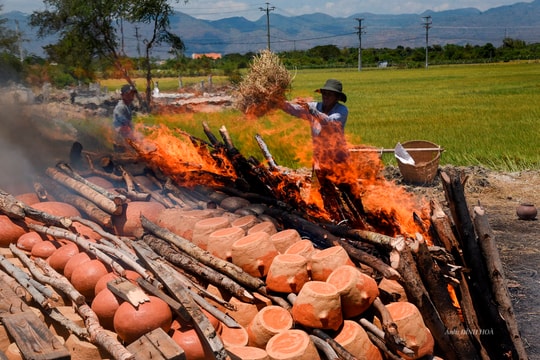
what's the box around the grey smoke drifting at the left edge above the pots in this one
[0,93,76,195]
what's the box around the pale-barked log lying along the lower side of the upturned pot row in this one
[141,216,265,297]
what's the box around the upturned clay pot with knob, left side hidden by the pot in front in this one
[326,265,379,319]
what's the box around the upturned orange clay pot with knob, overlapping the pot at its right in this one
[292,281,343,330]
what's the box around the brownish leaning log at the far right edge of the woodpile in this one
[474,206,528,359]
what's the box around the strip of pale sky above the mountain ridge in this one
[0,0,531,20]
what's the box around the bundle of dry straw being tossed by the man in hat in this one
[237,50,292,116]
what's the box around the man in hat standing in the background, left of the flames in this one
[113,84,137,150]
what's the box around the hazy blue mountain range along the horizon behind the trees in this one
[0,0,540,59]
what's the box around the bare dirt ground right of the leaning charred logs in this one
[396,167,540,360]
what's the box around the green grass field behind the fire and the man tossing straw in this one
[100,62,540,171]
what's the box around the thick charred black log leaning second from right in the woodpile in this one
[441,172,516,358]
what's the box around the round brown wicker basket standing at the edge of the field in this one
[397,140,442,185]
